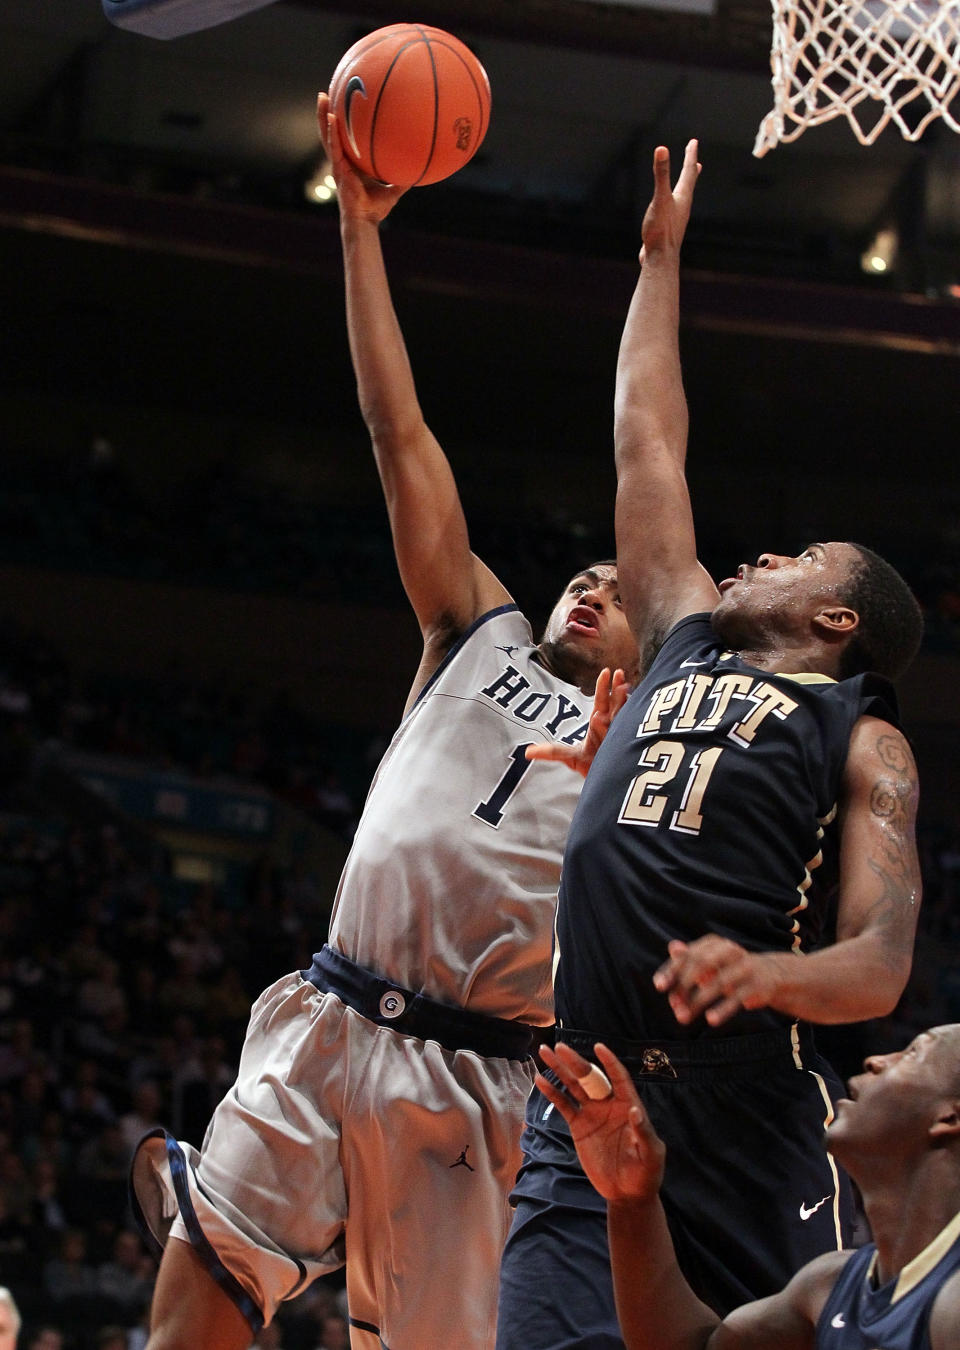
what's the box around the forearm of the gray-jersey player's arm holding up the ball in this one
[340,217,423,444]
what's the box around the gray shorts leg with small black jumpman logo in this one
[343,1018,532,1350]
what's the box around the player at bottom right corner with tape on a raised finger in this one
[537,1025,960,1350]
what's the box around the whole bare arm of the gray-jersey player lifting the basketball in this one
[317,93,509,678]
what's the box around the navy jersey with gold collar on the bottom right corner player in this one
[814,1214,960,1350]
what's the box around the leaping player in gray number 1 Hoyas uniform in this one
[127,95,637,1350]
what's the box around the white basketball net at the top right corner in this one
[753,0,960,158]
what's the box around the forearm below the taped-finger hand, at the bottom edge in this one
[606,1199,720,1350]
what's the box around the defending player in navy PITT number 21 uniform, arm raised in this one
[497,142,921,1350]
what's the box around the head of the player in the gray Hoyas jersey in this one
[540,560,639,691]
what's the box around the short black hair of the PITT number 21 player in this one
[838,541,924,679]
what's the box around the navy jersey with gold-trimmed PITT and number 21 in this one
[555,614,898,1041]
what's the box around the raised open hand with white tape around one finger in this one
[536,1041,667,1202]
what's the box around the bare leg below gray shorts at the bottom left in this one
[147,1238,254,1350]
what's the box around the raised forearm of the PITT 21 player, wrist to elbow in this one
[614,247,687,471]
